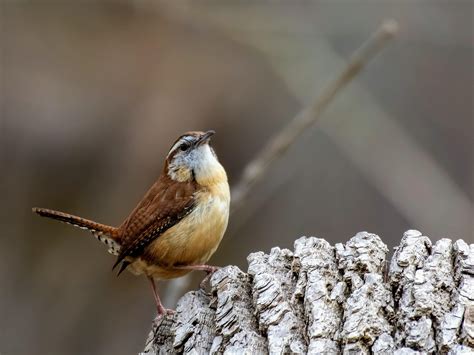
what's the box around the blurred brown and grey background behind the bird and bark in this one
[0,0,474,354]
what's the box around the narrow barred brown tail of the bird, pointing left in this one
[33,207,120,255]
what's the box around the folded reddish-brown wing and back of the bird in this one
[114,175,197,274]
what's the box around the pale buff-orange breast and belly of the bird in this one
[130,196,229,279]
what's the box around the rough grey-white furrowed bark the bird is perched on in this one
[143,230,474,355]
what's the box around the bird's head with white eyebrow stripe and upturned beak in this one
[165,131,227,185]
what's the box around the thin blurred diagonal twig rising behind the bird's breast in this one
[231,19,398,213]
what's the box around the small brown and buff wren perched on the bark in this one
[33,131,230,315]
